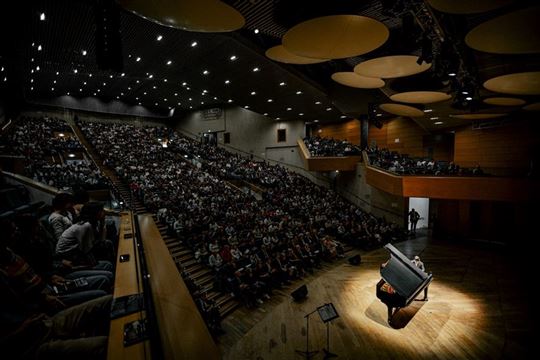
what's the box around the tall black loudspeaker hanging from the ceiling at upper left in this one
[94,0,124,72]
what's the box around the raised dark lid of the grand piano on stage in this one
[381,244,432,303]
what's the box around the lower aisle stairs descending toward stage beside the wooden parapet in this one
[153,215,240,318]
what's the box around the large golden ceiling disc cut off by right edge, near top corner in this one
[465,6,540,54]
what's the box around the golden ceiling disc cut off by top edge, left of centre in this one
[116,0,245,32]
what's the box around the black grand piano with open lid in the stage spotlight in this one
[377,244,433,324]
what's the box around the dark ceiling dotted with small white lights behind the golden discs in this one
[0,0,540,130]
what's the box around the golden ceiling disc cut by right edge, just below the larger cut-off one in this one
[484,71,540,95]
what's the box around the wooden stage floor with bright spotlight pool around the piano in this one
[220,238,532,360]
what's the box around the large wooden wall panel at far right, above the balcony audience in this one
[454,120,540,175]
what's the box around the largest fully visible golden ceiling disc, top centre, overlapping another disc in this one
[282,15,390,59]
